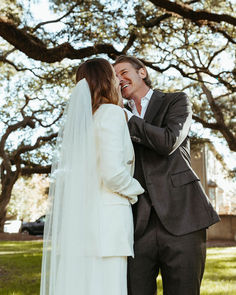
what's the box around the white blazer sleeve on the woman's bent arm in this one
[97,105,144,203]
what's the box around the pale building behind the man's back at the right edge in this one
[191,140,236,215]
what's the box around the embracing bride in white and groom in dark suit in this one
[40,56,219,295]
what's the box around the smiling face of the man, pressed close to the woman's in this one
[114,62,146,99]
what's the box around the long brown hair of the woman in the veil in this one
[76,58,119,113]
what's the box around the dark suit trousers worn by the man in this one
[128,208,206,295]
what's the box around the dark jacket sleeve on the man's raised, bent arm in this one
[128,92,192,156]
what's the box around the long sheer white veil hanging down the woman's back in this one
[40,79,100,295]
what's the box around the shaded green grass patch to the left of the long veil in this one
[0,241,42,295]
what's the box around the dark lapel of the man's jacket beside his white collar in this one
[144,90,165,123]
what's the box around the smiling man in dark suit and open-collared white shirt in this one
[114,56,219,295]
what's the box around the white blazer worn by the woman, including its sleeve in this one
[94,104,144,256]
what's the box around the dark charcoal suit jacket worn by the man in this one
[128,90,219,235]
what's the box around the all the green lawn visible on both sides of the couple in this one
[0,241,236,295]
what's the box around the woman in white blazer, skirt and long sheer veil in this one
[40,58,143,295]
